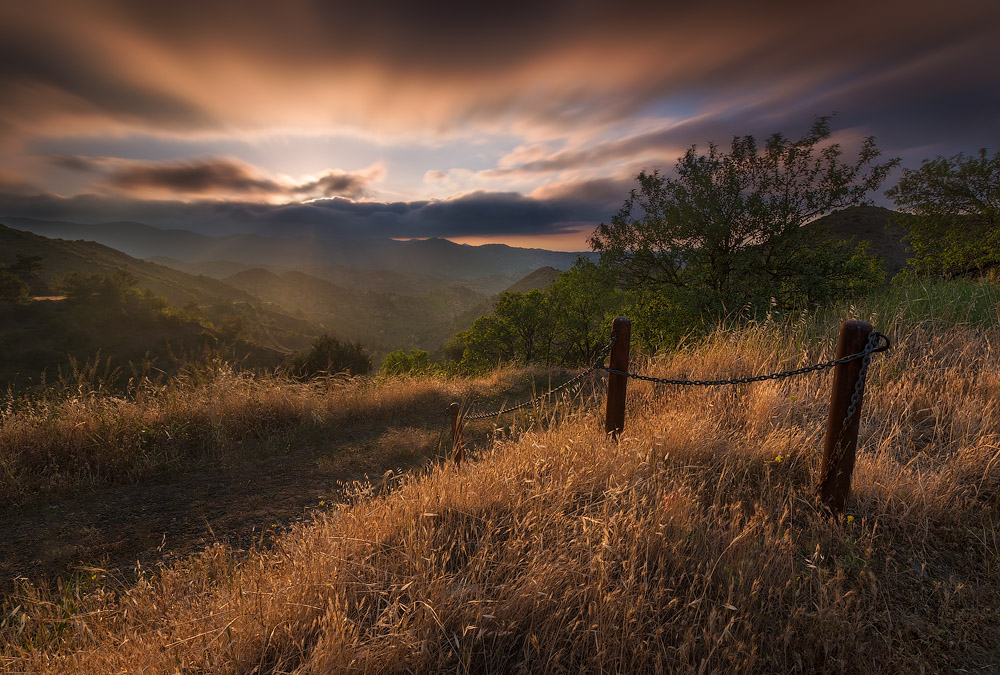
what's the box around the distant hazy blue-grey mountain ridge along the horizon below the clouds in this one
[3,218,578,279]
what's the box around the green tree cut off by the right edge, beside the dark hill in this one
[886,148,1000,277]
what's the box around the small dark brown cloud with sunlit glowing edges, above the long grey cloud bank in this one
[51,156,384,201]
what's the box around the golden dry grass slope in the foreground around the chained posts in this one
[3,284,1000,673]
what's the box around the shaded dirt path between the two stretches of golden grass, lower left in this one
[0,401,450,594]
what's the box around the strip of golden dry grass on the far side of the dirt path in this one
[0,361,556,507]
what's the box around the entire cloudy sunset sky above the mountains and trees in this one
[0,0,1000,250]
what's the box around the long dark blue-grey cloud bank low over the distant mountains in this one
[0,192,609,238]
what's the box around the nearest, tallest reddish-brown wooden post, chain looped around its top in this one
[819,321,872,513]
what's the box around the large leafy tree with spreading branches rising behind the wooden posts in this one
[590,117,898,344]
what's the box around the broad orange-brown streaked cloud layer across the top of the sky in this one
[0,0,1000,146]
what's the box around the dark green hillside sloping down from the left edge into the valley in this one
[0,225,321,382]
